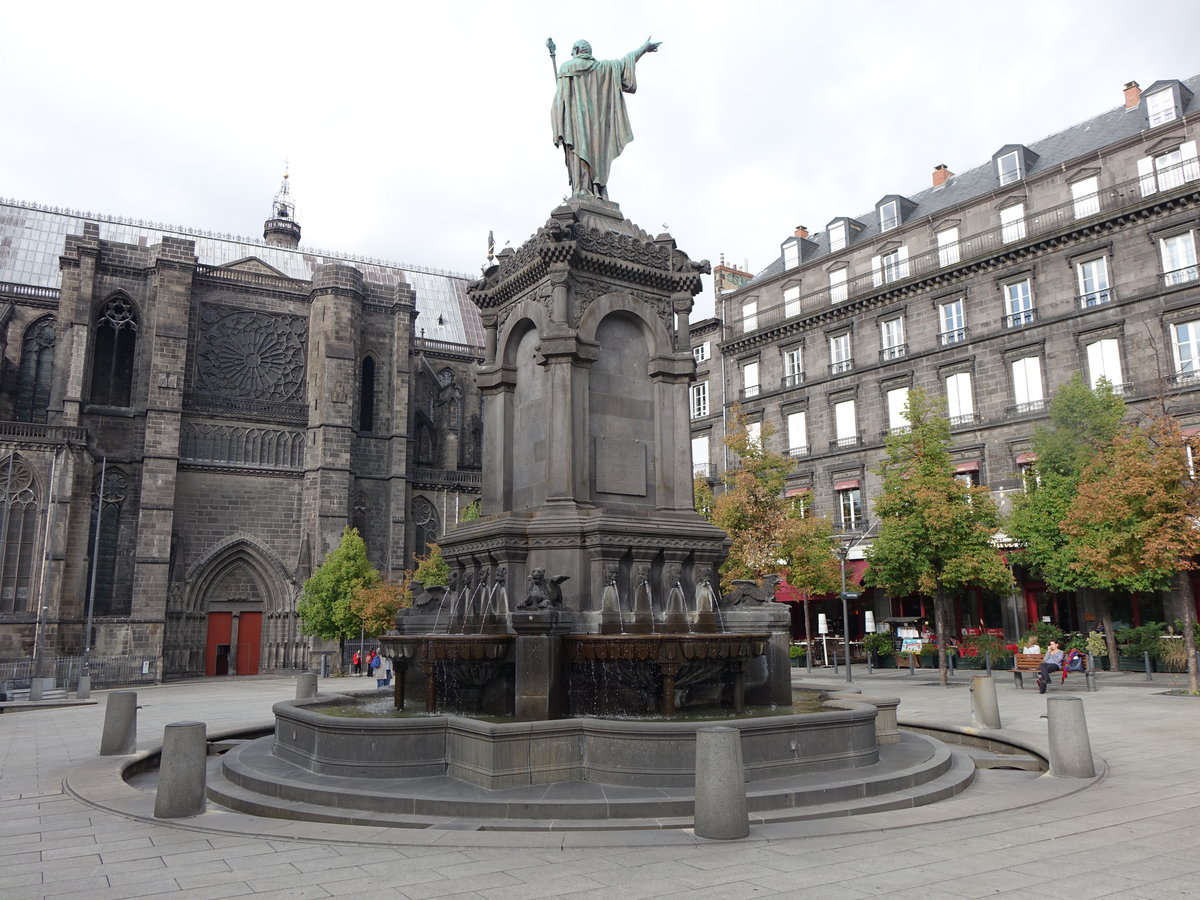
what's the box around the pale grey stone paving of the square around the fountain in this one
[0,668,1200,900]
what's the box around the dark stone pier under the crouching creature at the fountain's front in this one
[511,610,575,721]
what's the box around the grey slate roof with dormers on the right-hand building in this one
[750,74,1200,284]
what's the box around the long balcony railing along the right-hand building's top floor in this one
[725,160,1200,346]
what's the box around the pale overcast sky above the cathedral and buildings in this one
[0,0,1200,316]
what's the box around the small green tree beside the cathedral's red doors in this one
[296,528,379,671]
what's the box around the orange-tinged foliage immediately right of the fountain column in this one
[709,412,839,602]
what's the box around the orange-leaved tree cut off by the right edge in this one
[1062,413,1200,691]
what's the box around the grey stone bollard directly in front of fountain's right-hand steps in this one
[696,725,750,840]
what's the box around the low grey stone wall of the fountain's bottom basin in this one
[264,695,878,790]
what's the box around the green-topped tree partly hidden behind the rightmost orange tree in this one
[1006,374,1126,654]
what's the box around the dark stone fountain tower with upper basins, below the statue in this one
[382,196,791,720]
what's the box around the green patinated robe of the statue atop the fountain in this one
[550,52,637,193]
